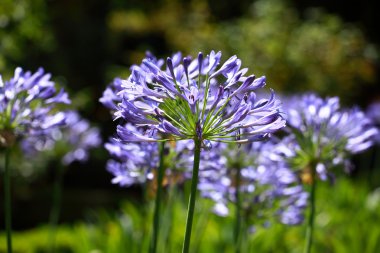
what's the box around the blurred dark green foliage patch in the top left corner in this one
[0,0,56,71]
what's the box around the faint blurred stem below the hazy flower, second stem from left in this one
[49,163,64,252]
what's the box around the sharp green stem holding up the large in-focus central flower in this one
[182,137,202,253]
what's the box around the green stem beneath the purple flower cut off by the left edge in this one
[4,147,12,253]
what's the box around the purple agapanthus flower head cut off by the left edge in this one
[0,68,70,146]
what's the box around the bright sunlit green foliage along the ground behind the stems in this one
[0,179,380,253]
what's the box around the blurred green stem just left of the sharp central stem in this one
[150,142,165,253]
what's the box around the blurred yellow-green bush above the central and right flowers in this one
[109,0,377,102]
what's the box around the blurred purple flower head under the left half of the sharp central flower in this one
[105,124,194,186]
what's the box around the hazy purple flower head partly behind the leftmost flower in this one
[21,111,102,165]
